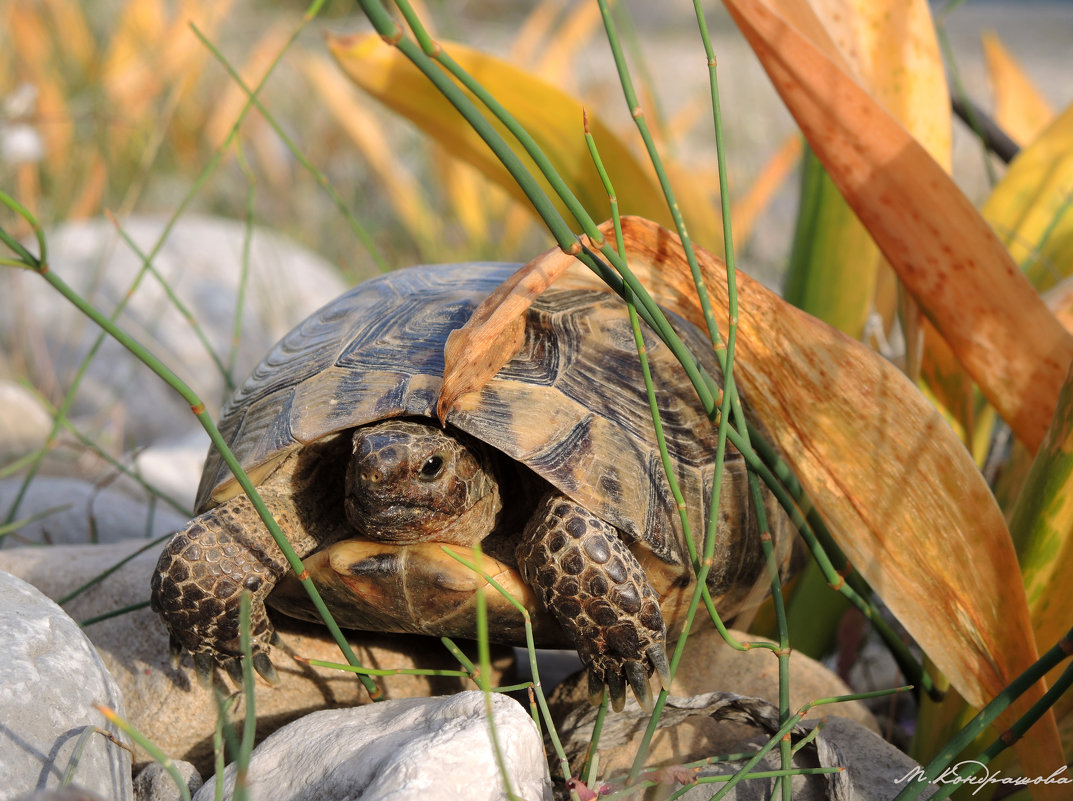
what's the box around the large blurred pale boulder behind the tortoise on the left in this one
[0,214,344,453]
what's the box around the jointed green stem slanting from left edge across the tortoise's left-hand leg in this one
[0,192,380,698]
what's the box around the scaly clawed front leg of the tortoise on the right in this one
[515,494,667,711]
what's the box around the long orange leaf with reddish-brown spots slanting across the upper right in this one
[726,0,1073,450]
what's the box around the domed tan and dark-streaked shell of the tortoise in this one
[197,263,745,581]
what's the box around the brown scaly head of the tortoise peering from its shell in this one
[346,419,502,545]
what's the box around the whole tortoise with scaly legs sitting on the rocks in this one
[151,263,789,708]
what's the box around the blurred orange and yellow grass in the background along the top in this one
[0,0,1073,287]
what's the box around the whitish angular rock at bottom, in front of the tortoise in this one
[194,691,550,801]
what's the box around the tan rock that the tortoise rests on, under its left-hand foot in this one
[0,540,511,775]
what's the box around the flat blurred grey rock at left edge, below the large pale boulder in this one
[0,476,188,547]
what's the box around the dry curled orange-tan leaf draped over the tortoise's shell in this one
[441,218,1034,720]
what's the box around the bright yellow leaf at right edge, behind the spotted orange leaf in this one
[983,105,1073,290]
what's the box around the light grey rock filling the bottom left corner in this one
[0,573,132,801]
